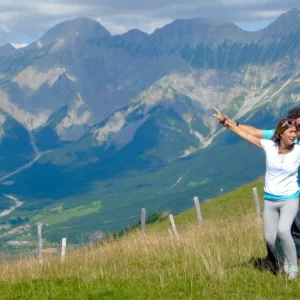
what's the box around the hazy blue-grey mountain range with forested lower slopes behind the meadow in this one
[0,9,300,242]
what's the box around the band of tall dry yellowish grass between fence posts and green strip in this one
[0,214,265,288]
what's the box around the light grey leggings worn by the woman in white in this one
[264,198,299,266]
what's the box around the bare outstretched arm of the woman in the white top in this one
[213,107,262,148]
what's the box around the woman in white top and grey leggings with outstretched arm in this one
[213,108,300,279]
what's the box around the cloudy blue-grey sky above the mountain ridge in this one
[0,0,300,47]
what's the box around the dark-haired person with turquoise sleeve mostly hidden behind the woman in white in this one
[221,106,300,273]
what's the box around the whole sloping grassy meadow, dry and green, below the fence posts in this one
[0,181,300,299]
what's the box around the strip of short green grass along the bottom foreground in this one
[0,266,299,300]
